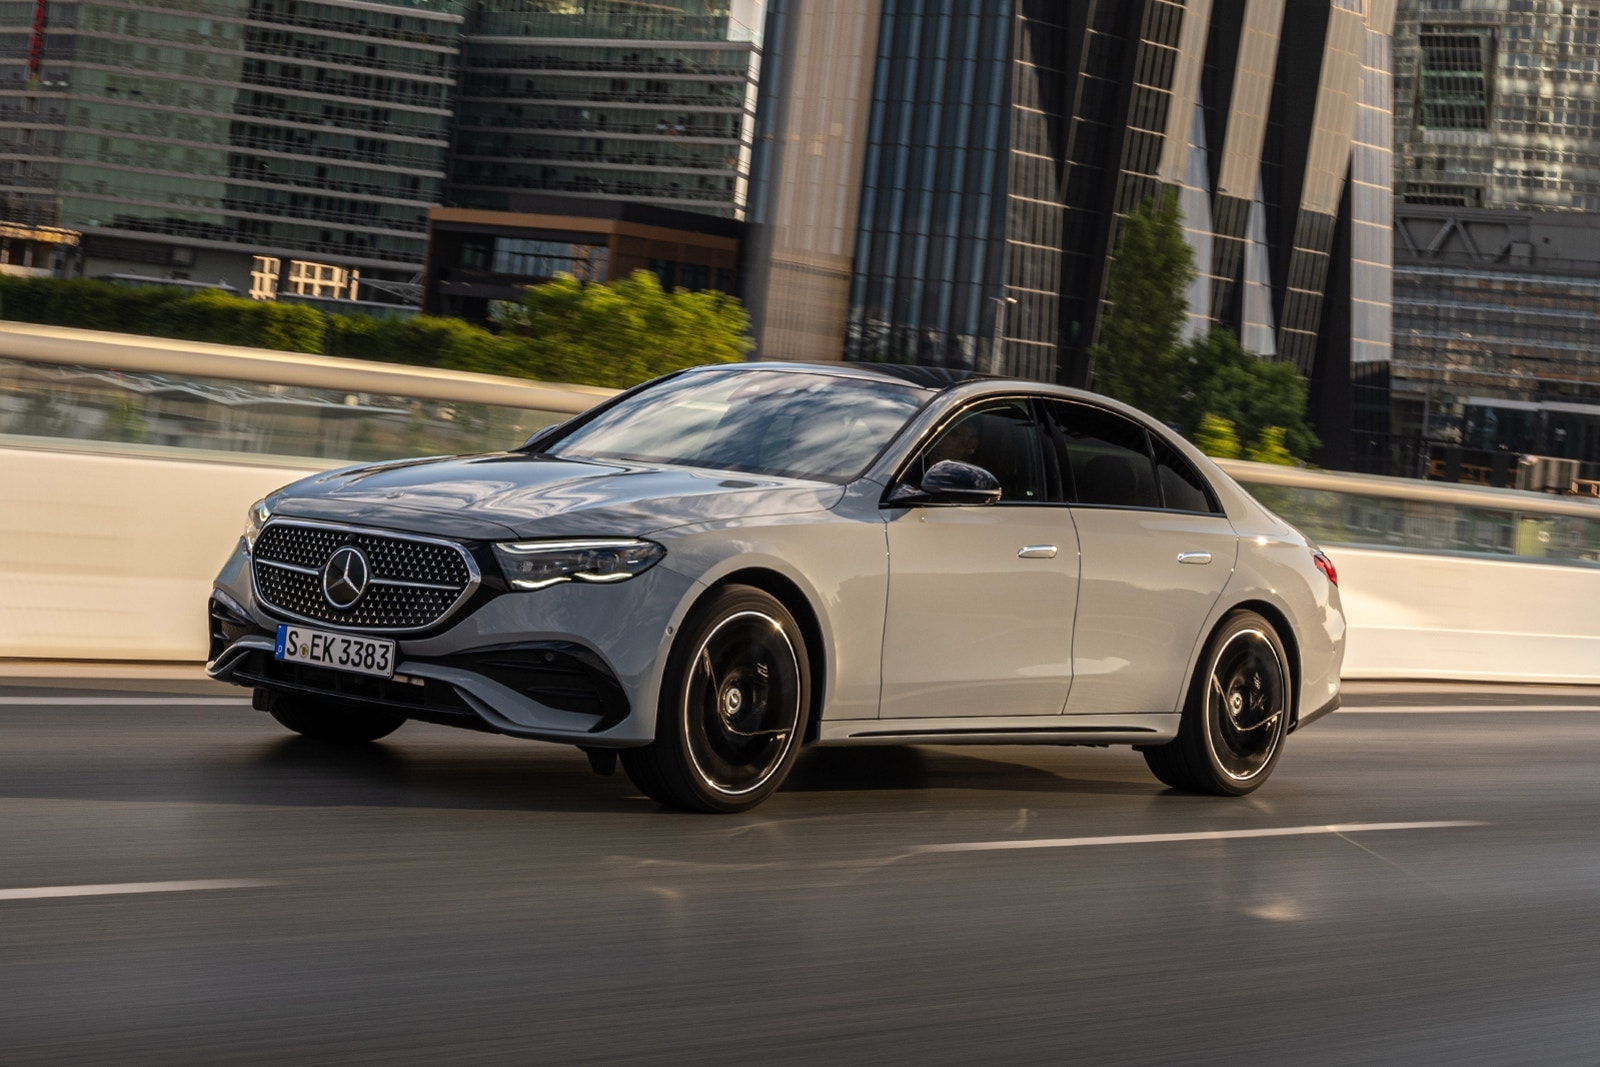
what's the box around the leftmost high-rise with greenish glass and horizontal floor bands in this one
[0,0,462,299]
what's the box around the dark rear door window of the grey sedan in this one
[1050,402,1162,507]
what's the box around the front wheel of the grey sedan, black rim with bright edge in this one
[621,585,811,813]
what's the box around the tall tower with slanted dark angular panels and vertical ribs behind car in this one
[747,0,1394,469]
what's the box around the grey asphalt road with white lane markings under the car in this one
[0,678,1600,1067]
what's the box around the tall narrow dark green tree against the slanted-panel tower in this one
[1091,194,1195,422]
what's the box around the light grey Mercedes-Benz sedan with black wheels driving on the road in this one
[208,363,1344,811]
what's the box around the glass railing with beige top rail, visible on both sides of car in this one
[0,323,1600,568]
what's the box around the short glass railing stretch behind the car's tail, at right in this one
[1222,462,1600,566]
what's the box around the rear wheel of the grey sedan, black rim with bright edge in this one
[1142,611,1291,797]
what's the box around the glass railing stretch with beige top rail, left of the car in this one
[0,323,608,466]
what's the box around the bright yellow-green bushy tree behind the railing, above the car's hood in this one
[489,270,755,387]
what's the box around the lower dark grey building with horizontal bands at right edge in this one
[1394,205,1600,483]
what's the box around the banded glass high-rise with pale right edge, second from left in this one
[450,0,765,218]
